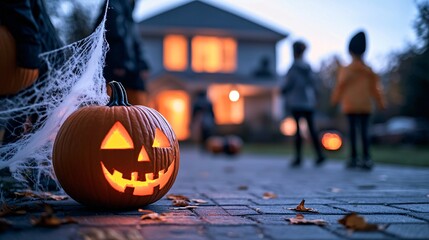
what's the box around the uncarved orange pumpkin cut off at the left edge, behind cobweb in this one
[0,26,39,95]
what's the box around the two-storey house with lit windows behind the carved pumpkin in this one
[139,1,287,140]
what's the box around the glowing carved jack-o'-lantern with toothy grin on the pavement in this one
[53,82,179,208]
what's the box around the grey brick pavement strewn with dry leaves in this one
[0,147,429,240]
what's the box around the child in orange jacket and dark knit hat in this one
[332,31,385,170]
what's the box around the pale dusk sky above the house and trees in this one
[135,0,417,74]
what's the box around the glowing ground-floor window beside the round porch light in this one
[208,85,244,124]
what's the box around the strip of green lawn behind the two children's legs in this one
[243,142,429,167]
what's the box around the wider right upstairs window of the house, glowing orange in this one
[192,36,237,73]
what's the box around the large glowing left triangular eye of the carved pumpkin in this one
[101,121,134,149]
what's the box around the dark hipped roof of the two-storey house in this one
[139,1,287,41]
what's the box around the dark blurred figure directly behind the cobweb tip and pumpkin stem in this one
[98,0,149,105]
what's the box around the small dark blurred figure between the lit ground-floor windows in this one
[191,90,215,149]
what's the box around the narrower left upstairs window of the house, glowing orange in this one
[164,35,188,71]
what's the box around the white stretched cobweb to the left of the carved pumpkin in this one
[0,5,108,191]
